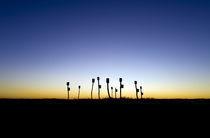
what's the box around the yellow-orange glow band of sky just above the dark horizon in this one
[0,84,210,99]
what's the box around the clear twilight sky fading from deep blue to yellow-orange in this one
[0,0,210,99]
